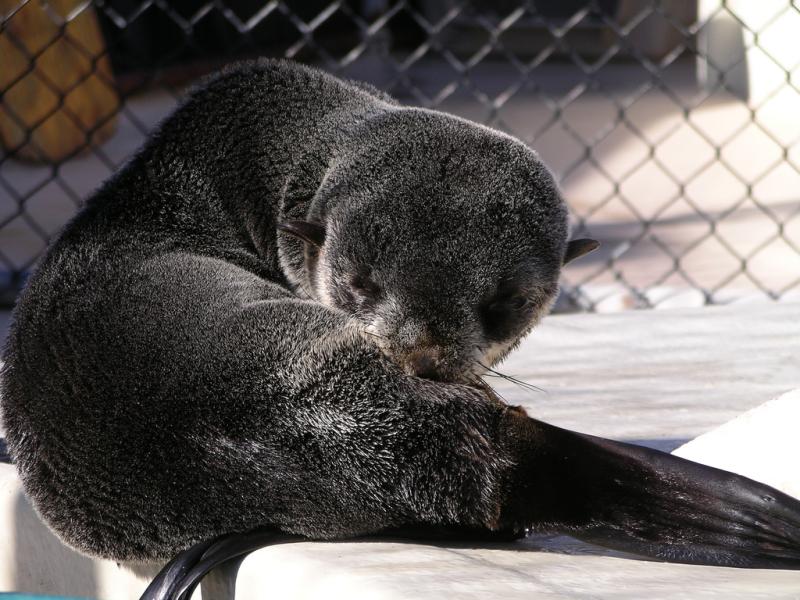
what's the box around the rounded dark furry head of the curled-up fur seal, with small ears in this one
[281,108,595,382]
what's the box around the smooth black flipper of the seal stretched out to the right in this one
[500,409,800,569]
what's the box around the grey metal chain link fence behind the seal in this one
[0,0,800,310]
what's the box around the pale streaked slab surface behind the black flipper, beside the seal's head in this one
[488,303,800,440]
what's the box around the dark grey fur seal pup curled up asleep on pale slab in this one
[2,61,800,568]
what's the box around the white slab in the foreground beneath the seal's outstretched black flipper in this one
[230,540,800,600]
